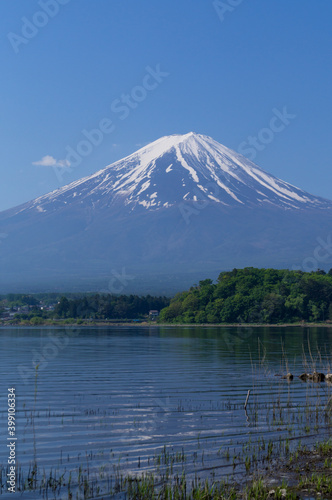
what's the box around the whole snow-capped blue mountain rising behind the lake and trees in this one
[0,132,332,292]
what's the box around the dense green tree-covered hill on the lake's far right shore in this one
[159,267,332,323]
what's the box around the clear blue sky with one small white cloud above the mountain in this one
[0,0,332,210]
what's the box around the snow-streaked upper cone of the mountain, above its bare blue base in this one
[10,132,332,213]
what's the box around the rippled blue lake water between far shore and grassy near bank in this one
[0,326,332,499]
